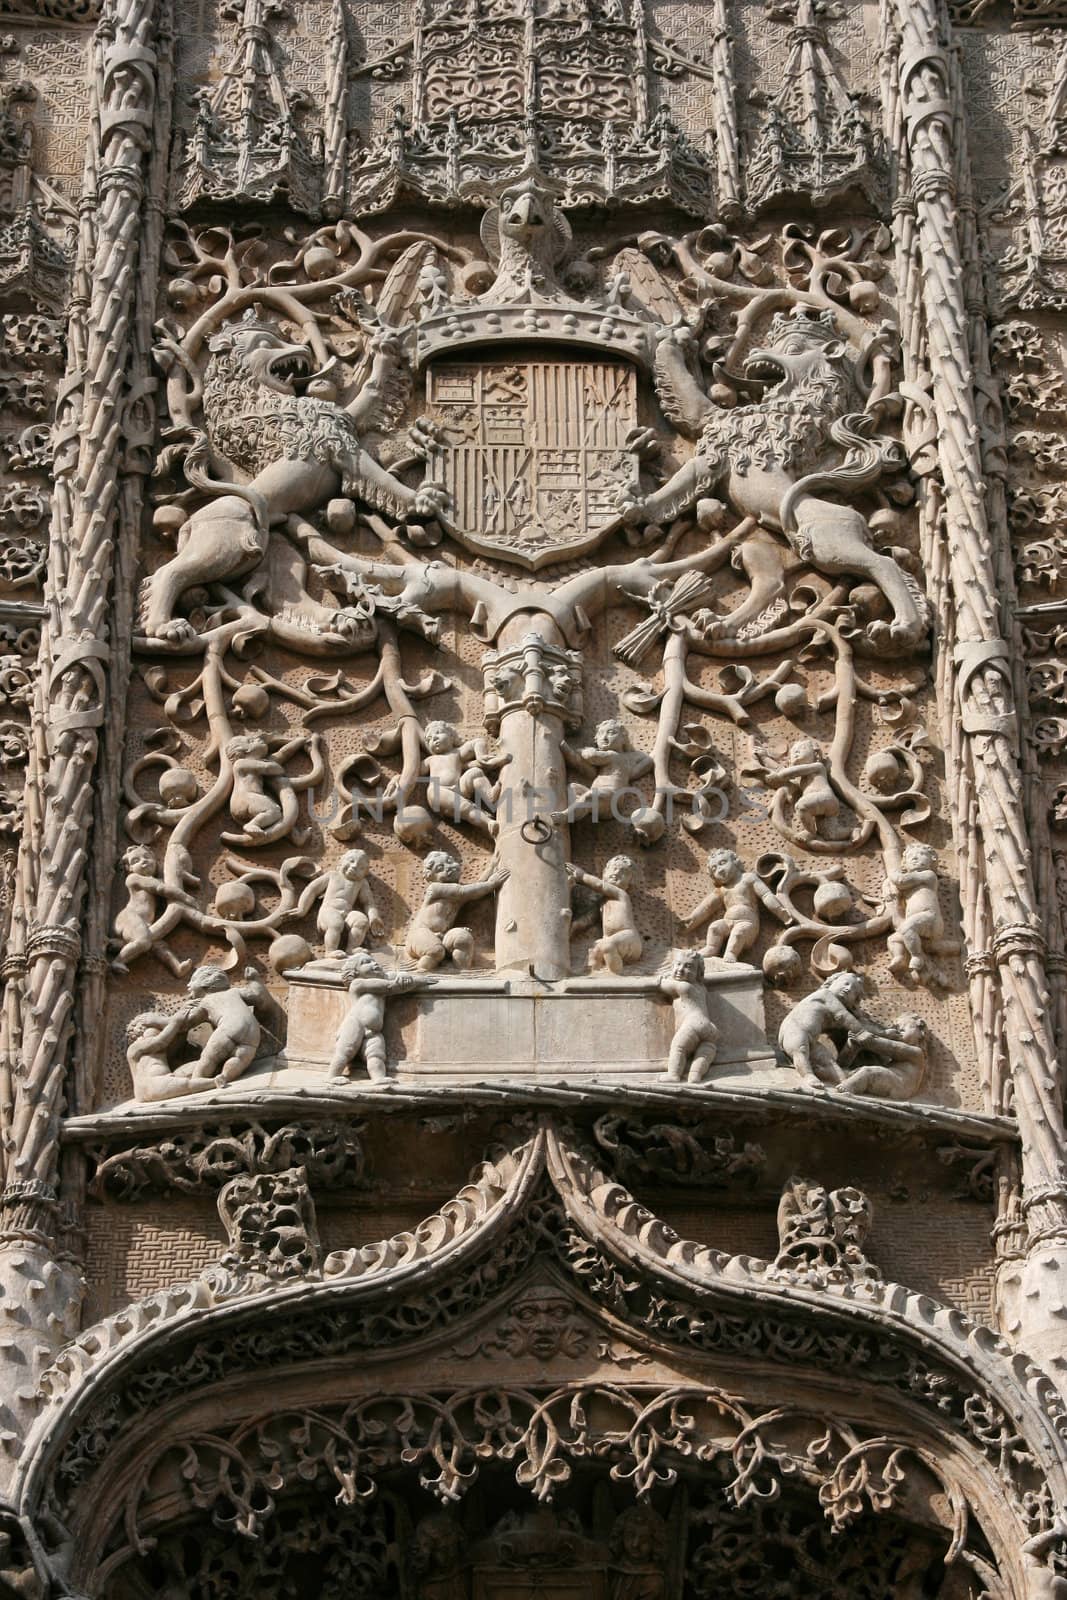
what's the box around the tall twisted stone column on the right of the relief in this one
[896,0,1067,1381]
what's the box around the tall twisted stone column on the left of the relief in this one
[0,0,160,1465]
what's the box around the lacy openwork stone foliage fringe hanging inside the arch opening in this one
[119,1386,965,1547]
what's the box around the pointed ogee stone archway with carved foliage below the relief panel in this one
[22,1120,1062,1600]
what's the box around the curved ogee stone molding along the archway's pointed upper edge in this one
[22,1130,1067,1542]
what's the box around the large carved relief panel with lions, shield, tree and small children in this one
[83,173,979,1099]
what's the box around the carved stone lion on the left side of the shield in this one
[141,314,446,643]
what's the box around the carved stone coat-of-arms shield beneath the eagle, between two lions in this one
[427,358,637,570]
